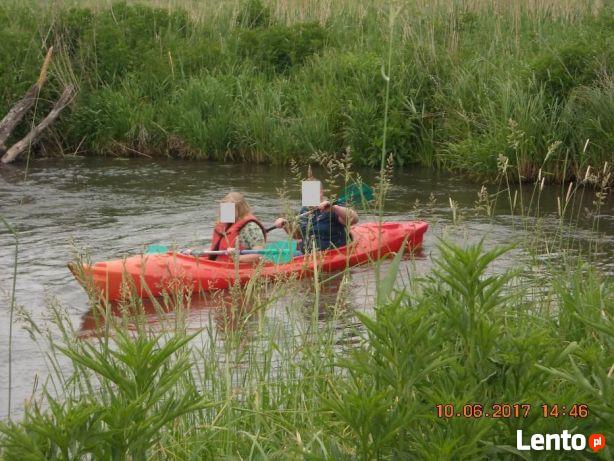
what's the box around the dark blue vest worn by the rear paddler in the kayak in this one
[299,207,348,252]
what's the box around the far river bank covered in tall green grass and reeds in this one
[0,0,614,182]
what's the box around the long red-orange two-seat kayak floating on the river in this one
[68,221,428,301]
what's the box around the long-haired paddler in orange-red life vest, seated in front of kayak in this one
[209,192,266,264]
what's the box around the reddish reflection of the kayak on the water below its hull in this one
[79,271,350,338]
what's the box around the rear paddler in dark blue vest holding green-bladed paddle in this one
[275,178,358,252]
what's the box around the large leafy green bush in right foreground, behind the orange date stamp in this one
[326,242,614,459]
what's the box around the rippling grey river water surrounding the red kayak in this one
[0,158,614,418]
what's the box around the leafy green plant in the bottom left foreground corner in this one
[0,330,208,460]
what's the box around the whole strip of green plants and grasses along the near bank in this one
[0,242,614,461]
